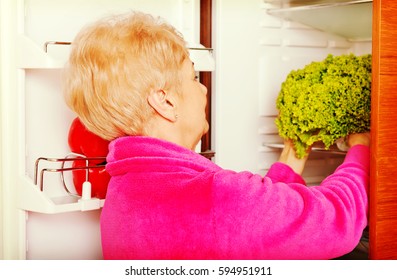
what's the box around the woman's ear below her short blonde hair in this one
[147,89,178,122]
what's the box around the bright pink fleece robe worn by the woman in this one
[101,137,369,259]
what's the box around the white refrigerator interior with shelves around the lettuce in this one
[212,0,372,179]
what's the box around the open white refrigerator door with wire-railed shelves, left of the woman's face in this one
[0,0,201,259]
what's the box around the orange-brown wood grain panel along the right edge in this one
[369,0,397,259]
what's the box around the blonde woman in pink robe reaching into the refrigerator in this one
[65,10,369,259]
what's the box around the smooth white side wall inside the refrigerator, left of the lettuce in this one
[213,0,262,171]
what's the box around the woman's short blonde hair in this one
[64,12,189,140]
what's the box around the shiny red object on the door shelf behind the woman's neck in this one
[68,118,110,199]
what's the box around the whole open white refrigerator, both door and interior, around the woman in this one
[0,0,372,260]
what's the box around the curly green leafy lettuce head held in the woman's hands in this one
[275,54,371,158]
